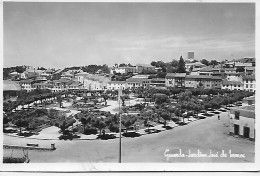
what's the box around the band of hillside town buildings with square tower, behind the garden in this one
[4,52,255,94]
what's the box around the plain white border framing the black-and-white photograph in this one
[0,0,260,172]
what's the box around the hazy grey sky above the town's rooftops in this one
[3,2,255,68]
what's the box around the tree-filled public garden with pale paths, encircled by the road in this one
[3,87,253,140]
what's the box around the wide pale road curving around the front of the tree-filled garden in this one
[4,113,255,163]
